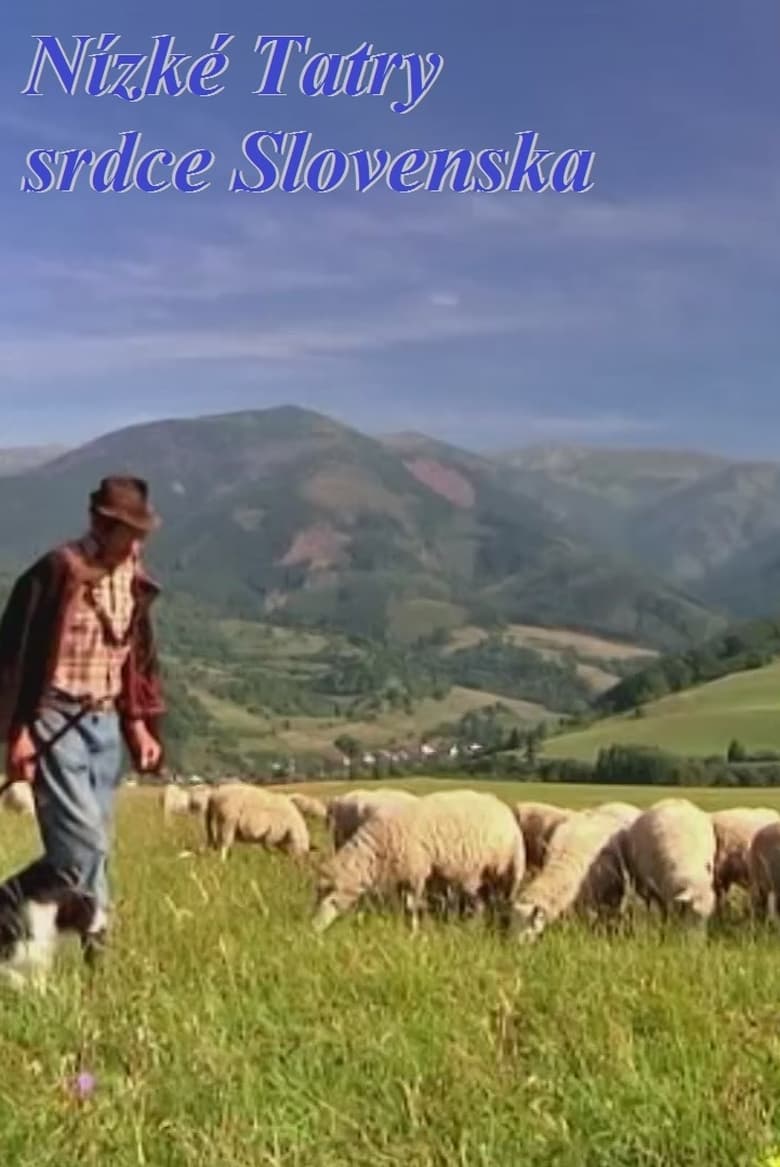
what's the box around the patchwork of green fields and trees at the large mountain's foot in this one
[160,611,625,770]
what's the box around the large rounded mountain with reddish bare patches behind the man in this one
[0,406,722,649]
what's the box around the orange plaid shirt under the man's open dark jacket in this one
[51,536,135,703]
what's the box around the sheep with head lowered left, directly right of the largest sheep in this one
[513,806,627,943]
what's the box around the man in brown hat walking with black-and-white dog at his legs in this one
[0,476,165,980]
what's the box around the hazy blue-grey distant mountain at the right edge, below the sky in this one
[494,446,780,617]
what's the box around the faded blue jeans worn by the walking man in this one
[8,699,121,916]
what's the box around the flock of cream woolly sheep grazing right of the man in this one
[162,783,780,941]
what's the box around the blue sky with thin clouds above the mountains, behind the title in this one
[0,0,780,456]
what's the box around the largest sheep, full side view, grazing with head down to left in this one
[313,790,525,934]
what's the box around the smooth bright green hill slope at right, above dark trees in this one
[544,662,780,760]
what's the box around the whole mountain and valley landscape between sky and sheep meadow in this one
[12,406,780,767]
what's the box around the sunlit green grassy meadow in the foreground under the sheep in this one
[0,782,780,1167]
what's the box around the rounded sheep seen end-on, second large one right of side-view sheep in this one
[624,798,716,927]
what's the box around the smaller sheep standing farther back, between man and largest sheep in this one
[206,783,311,862]
